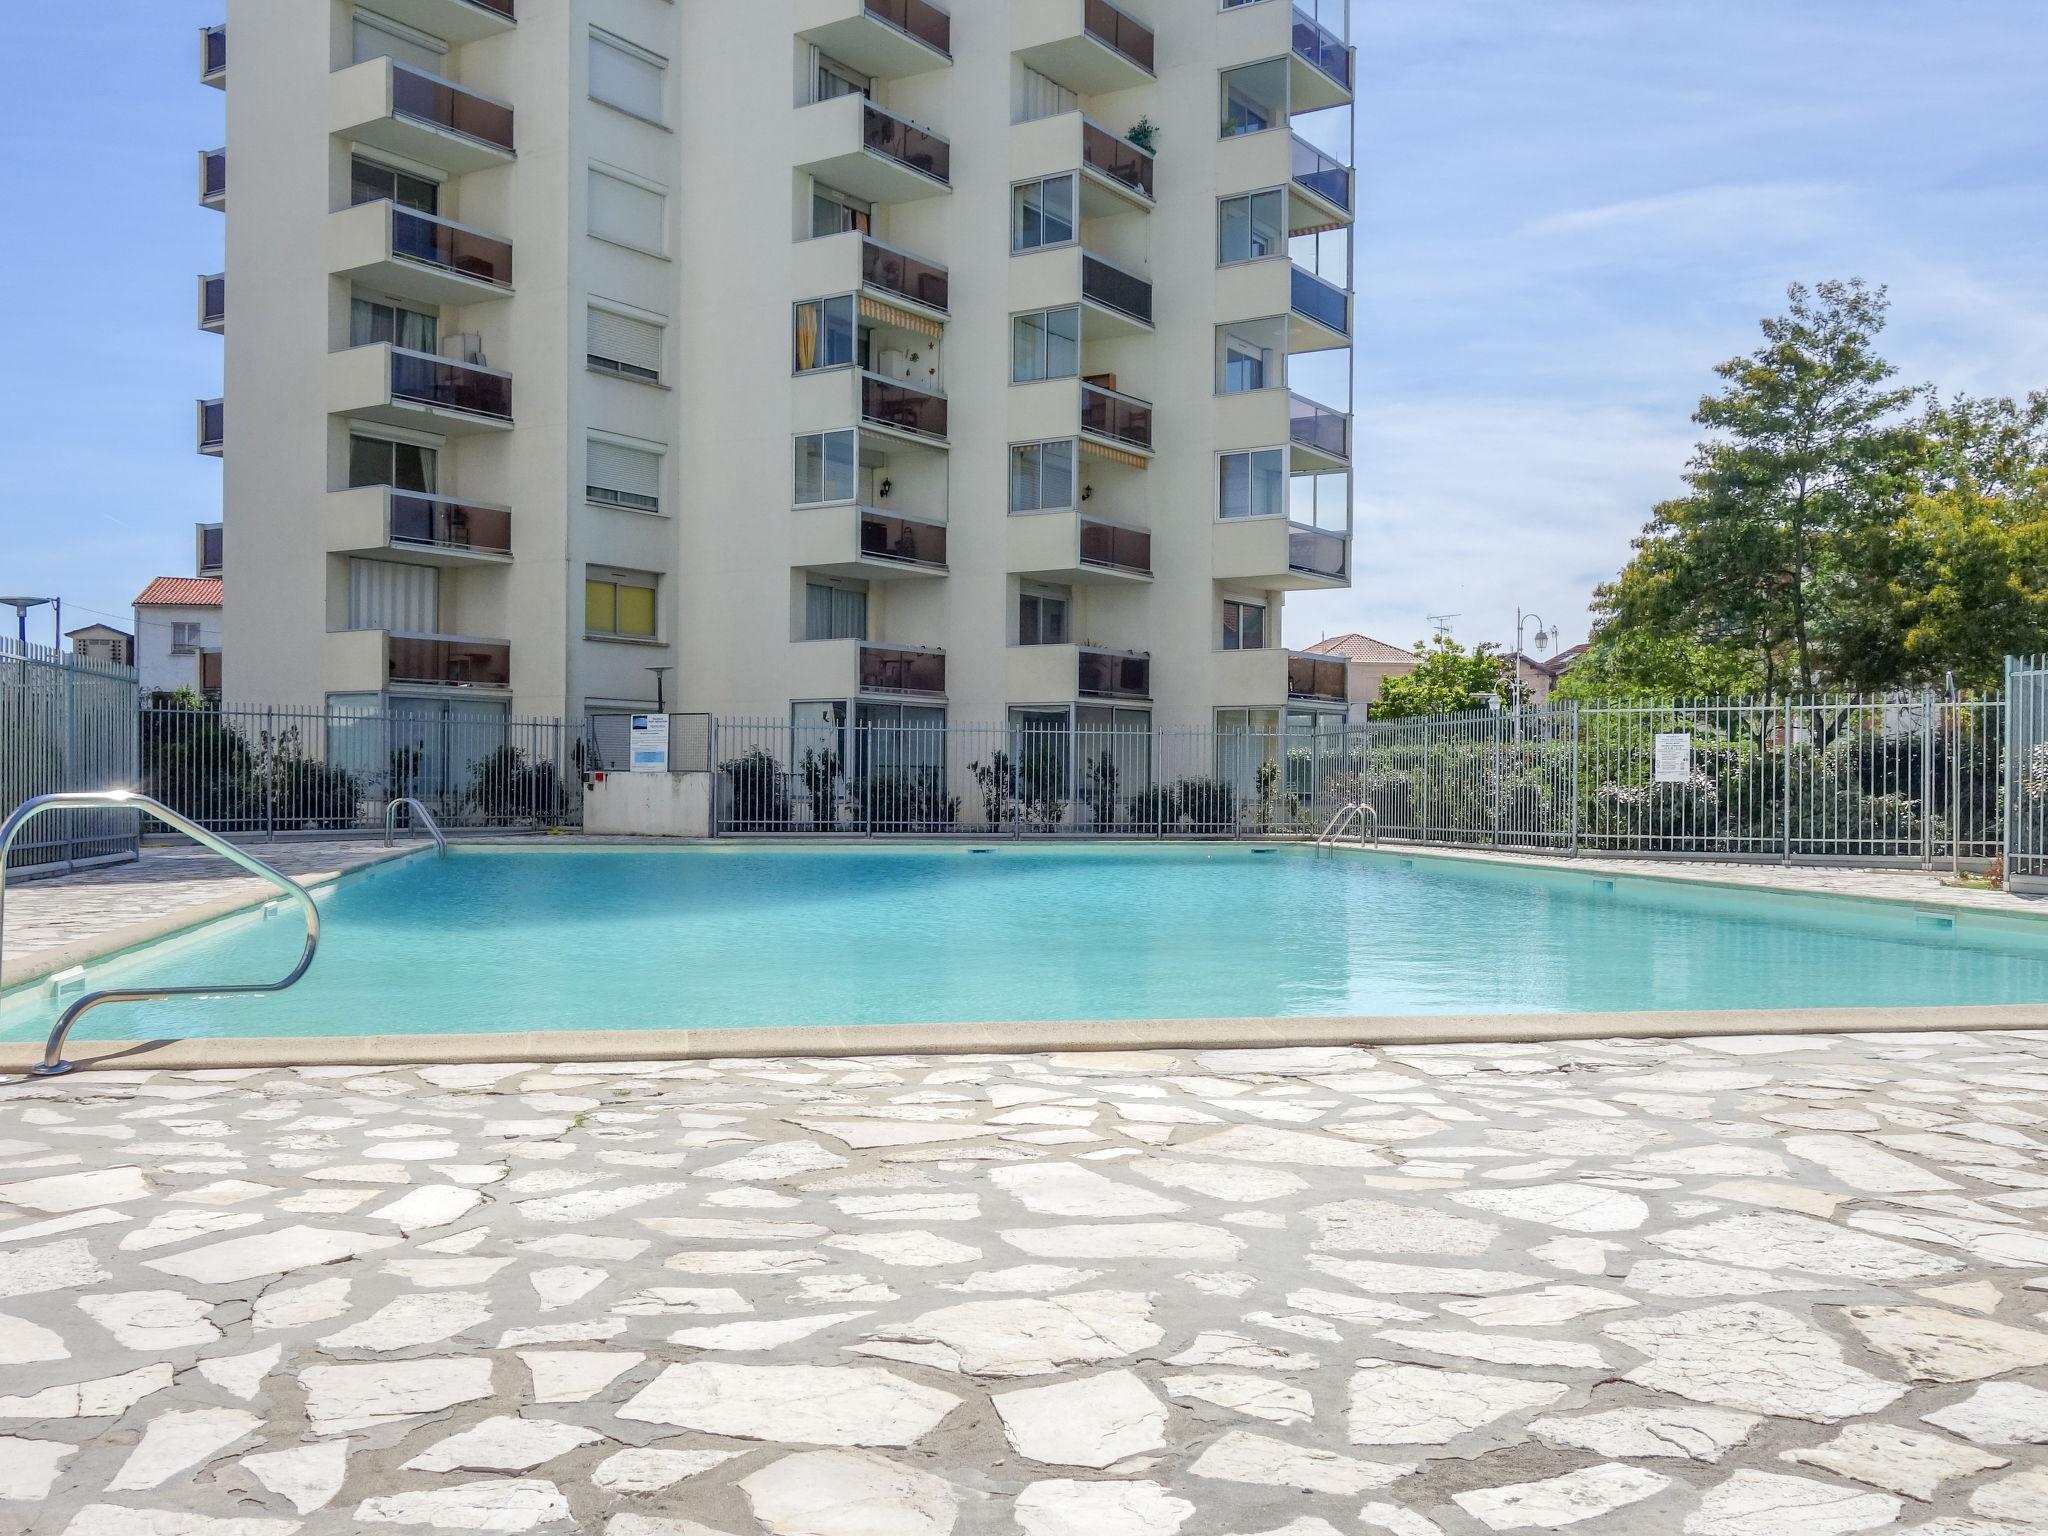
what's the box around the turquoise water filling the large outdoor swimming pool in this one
[0,846,2048,1040]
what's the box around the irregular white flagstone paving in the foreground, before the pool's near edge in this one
[0,1032,2048,1536]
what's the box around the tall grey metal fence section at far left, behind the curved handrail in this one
[0,637,137,870]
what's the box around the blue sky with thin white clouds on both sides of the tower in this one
[0,0,2048,663]
